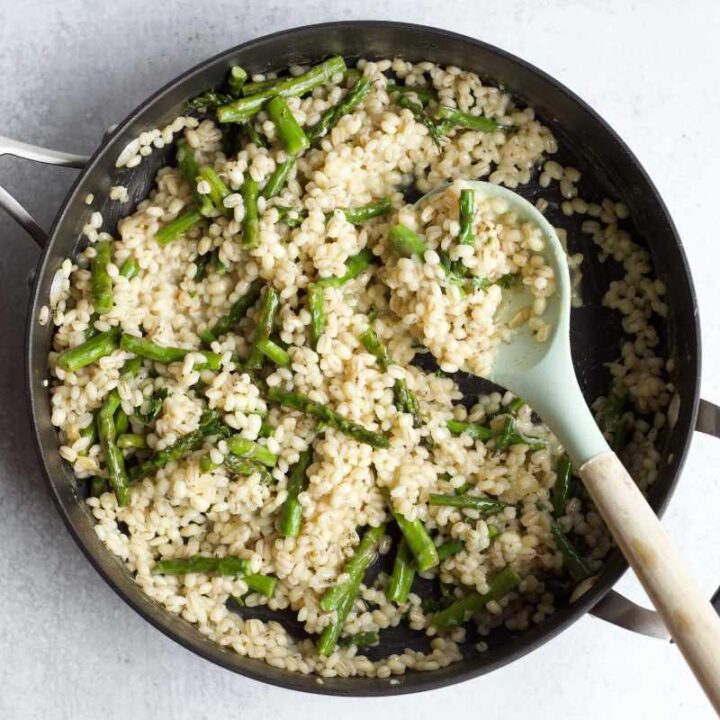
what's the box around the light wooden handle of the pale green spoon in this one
[580,452,720,714]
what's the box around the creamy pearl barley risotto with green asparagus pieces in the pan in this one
[46,58,673,677]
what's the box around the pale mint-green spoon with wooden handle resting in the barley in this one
[416,181,720,713]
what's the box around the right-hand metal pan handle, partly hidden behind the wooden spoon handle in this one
[590,400,720,640]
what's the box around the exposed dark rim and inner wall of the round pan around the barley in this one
[29,23,698,695]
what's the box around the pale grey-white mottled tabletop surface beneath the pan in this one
[0,0,720,720]
